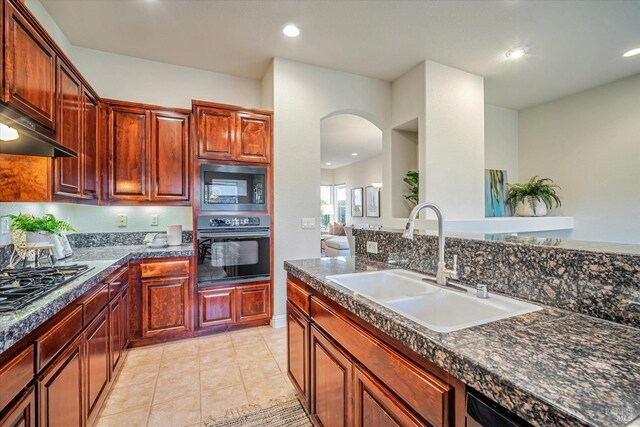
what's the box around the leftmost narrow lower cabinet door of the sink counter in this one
[287,301,309,408]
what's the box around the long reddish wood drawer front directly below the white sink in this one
[311,297,451,426]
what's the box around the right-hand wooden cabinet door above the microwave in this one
[235,113,271,163]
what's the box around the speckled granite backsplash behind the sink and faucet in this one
[354,230,640,327]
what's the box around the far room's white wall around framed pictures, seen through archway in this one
[333,154,384,226]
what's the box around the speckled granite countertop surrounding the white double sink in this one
[285,257,640,426]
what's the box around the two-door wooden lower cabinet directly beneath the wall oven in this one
[198,282,271,328]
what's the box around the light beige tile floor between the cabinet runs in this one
[97,326,293,427]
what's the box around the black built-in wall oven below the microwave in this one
[197,215,271,287]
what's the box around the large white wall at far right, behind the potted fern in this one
[518,74,640,243]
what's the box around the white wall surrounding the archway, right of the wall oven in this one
[273,58,391,315]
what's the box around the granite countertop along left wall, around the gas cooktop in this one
[0,244,194,354]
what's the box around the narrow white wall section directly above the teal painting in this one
[484,104,518,183]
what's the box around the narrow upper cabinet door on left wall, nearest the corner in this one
[81,89,99,198]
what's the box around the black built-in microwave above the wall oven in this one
[200,165,268,211]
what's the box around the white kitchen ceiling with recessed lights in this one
[41,0,640,109]
